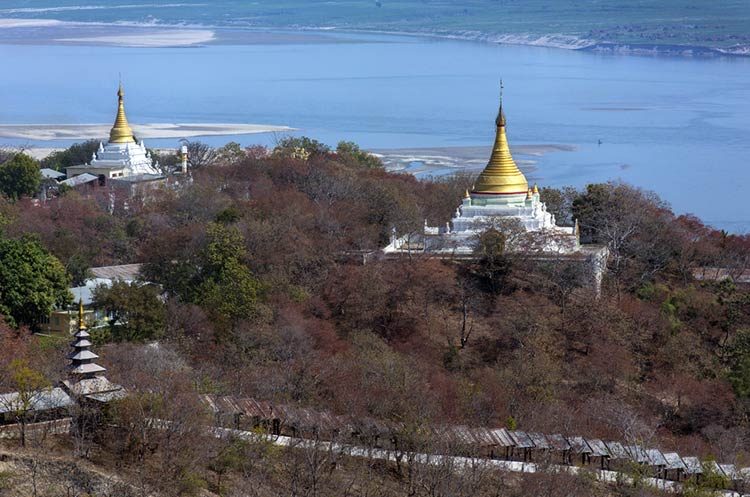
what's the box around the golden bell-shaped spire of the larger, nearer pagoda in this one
[473,81,529,194]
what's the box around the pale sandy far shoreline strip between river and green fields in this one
[0,18,750,57]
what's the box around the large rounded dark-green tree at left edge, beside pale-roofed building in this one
[0,237,73,329]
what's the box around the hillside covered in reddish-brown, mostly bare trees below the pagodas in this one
[0,138,750,496]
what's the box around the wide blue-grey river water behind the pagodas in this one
[0,23,750,232]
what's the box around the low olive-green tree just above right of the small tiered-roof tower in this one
[94,281,167,342]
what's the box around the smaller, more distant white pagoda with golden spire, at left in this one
[66,85,161,179]
